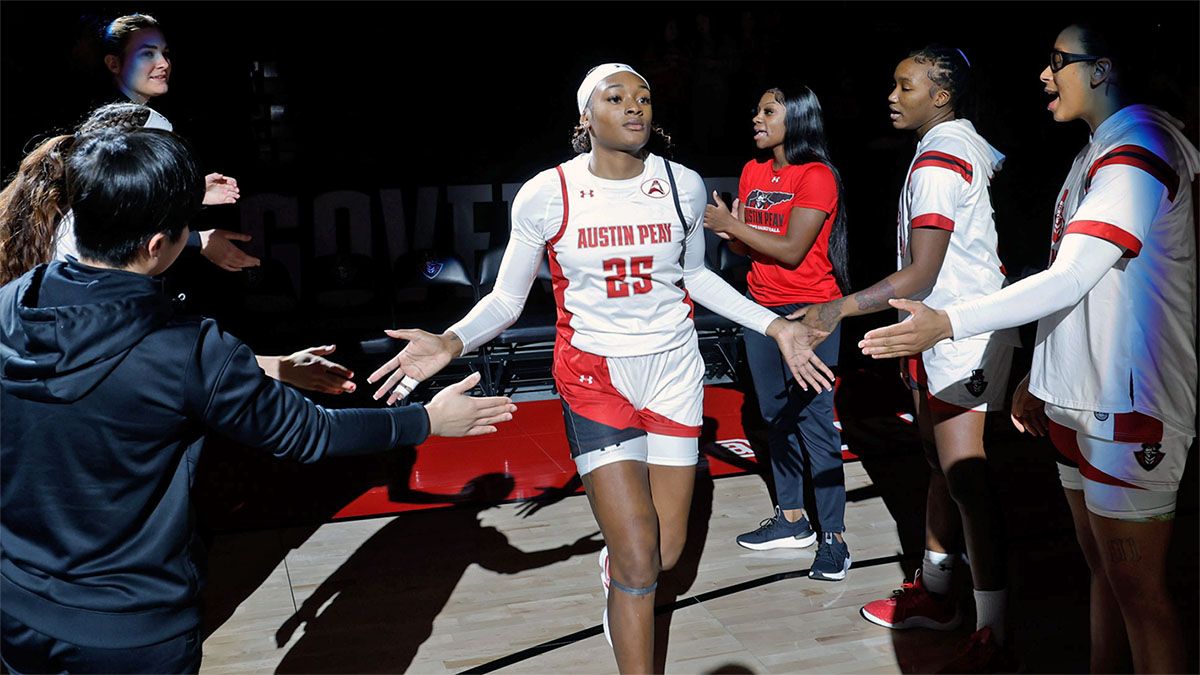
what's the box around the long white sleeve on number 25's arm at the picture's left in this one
[449,169,563,354]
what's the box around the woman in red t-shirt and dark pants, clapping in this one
[704,85,850,581]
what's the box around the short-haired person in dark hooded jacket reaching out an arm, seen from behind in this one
[0,130,515,673]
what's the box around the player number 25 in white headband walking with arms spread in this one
[367,64,833,673]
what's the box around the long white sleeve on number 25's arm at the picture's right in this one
[676,165,779,335]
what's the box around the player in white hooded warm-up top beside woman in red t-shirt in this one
[805,46,1015,671]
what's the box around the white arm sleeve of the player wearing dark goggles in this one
[946,233,1124,340]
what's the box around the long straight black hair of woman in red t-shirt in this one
[767,84,850,293]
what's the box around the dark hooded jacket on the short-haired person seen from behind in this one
[0,261,430,647]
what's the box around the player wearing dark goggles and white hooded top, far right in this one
[863,25,1200,673]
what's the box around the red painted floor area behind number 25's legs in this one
[334,386,873,520]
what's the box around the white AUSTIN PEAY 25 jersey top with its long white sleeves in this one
[450,154,778,357]
